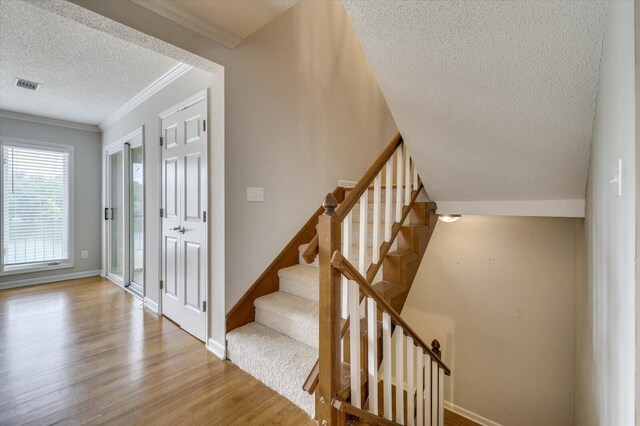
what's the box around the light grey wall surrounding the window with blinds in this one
[0,118,102,286]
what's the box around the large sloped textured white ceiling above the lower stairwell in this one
[344,0,606,213]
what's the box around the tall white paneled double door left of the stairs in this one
[161,100,207,341]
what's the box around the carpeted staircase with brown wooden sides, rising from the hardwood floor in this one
[227,131,448,425]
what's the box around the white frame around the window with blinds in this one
[0,136,75,276]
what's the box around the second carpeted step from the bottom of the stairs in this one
[254,291,318,348]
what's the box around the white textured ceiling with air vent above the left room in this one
[0,0,178,125]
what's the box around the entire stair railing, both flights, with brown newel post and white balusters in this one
[314,134,449,426]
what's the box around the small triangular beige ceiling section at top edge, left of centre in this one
[131,0,298,48]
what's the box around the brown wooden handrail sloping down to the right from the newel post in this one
[331,250,451,376]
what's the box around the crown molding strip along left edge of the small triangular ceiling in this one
[131,0,242,49]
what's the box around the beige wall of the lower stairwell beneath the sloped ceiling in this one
[402,216,582,426]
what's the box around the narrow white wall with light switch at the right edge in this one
[575,1,637,426]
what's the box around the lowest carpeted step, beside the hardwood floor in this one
[227,322,318,416]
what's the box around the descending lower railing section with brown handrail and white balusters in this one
[331,250,451,426]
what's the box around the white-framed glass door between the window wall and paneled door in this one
[104,129,144,297]
